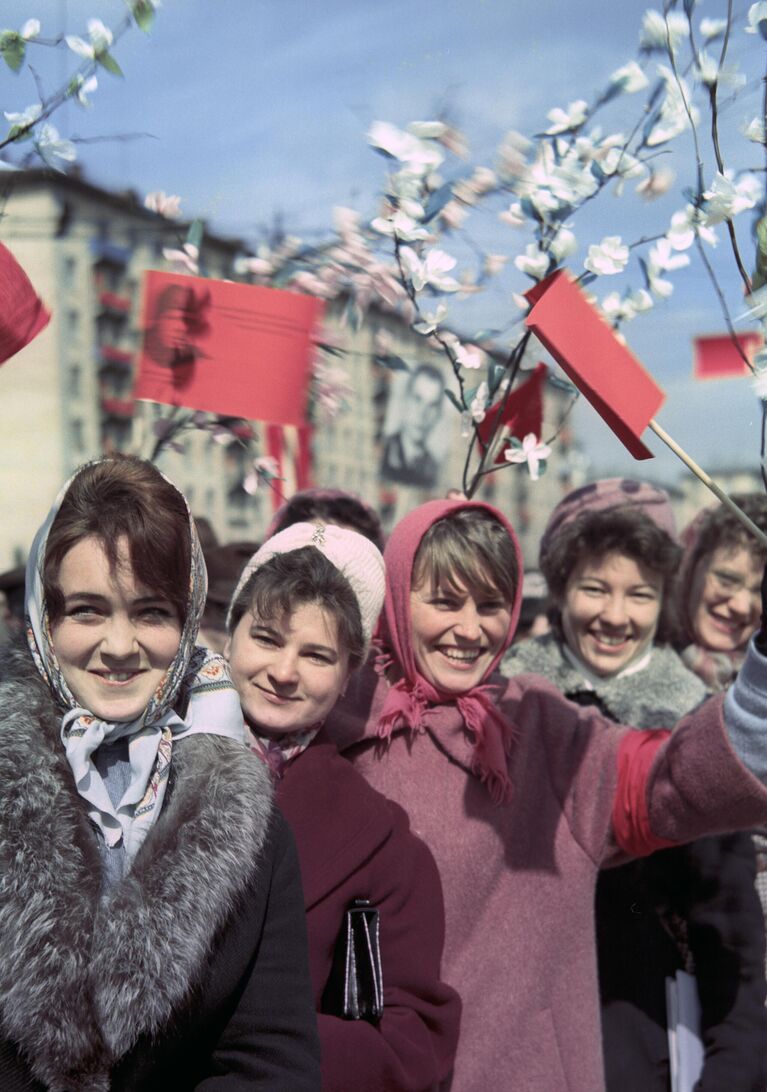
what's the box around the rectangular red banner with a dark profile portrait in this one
[134,271,322,426]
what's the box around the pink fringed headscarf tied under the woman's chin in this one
[377,500,524,803]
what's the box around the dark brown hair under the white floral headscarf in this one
[43,455,191,625]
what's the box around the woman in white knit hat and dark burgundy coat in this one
[225,523,460,1092]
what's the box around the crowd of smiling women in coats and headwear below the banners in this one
[0,455,767,1092]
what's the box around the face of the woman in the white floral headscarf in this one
[51,536,181,722]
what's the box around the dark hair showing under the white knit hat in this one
[229,546,365,670]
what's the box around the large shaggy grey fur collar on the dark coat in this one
[0,642,272,1092]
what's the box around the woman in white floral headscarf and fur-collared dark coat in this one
[0,456,319,1092]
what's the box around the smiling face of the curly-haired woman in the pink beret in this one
[562,554,663,678]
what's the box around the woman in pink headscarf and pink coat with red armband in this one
[329,500,767,1092]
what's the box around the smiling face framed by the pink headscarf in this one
[410,579,511,695]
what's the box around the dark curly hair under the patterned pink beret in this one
[540,505,682,644]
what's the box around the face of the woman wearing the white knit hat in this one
[224,603,349,736]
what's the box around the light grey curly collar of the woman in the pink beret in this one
[500,633,708,728]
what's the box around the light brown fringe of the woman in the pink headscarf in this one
[412,508,520,604]
